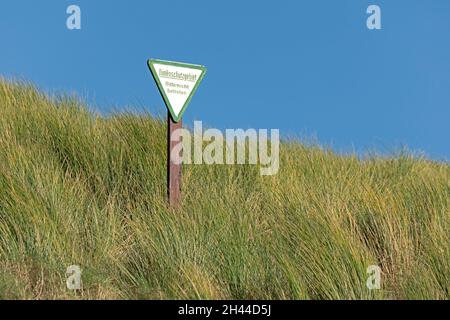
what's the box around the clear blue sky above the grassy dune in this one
[0,0,450,160]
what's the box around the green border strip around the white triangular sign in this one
[147,59,206,122]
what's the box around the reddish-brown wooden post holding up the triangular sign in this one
[167,112,182,208]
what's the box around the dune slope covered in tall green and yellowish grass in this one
[0,81,450,299]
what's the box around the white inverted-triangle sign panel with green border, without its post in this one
[148,59,206,122]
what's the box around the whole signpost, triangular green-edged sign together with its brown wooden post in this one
[147,59,206,208]
